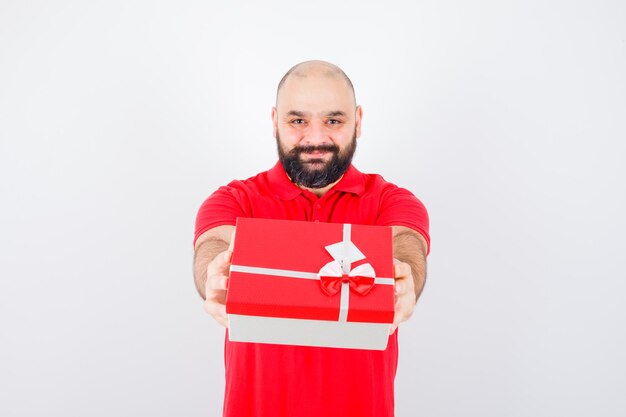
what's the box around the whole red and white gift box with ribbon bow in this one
[226,218,394,350]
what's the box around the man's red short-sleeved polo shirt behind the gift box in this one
[194,163,430,417]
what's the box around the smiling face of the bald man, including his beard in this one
[272,74,362,188]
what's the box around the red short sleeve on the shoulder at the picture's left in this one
[193,183,245,245]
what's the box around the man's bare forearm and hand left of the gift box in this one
[193,226,235,327]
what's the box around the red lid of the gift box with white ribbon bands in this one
[226,218,394,323]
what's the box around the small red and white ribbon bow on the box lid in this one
[318,261,376,296]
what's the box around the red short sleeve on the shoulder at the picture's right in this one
[376,187,430,253]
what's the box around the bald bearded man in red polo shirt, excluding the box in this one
[194,61,429,417]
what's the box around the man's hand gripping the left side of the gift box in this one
[204,231,235,328]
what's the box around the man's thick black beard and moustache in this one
[276,132,356,188]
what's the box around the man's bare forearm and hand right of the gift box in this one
[391,226,427,333]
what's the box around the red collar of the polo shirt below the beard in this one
[267,161,365,200]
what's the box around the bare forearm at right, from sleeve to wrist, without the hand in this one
[392,226,426,301]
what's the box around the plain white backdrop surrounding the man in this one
[0,0,626,417]
